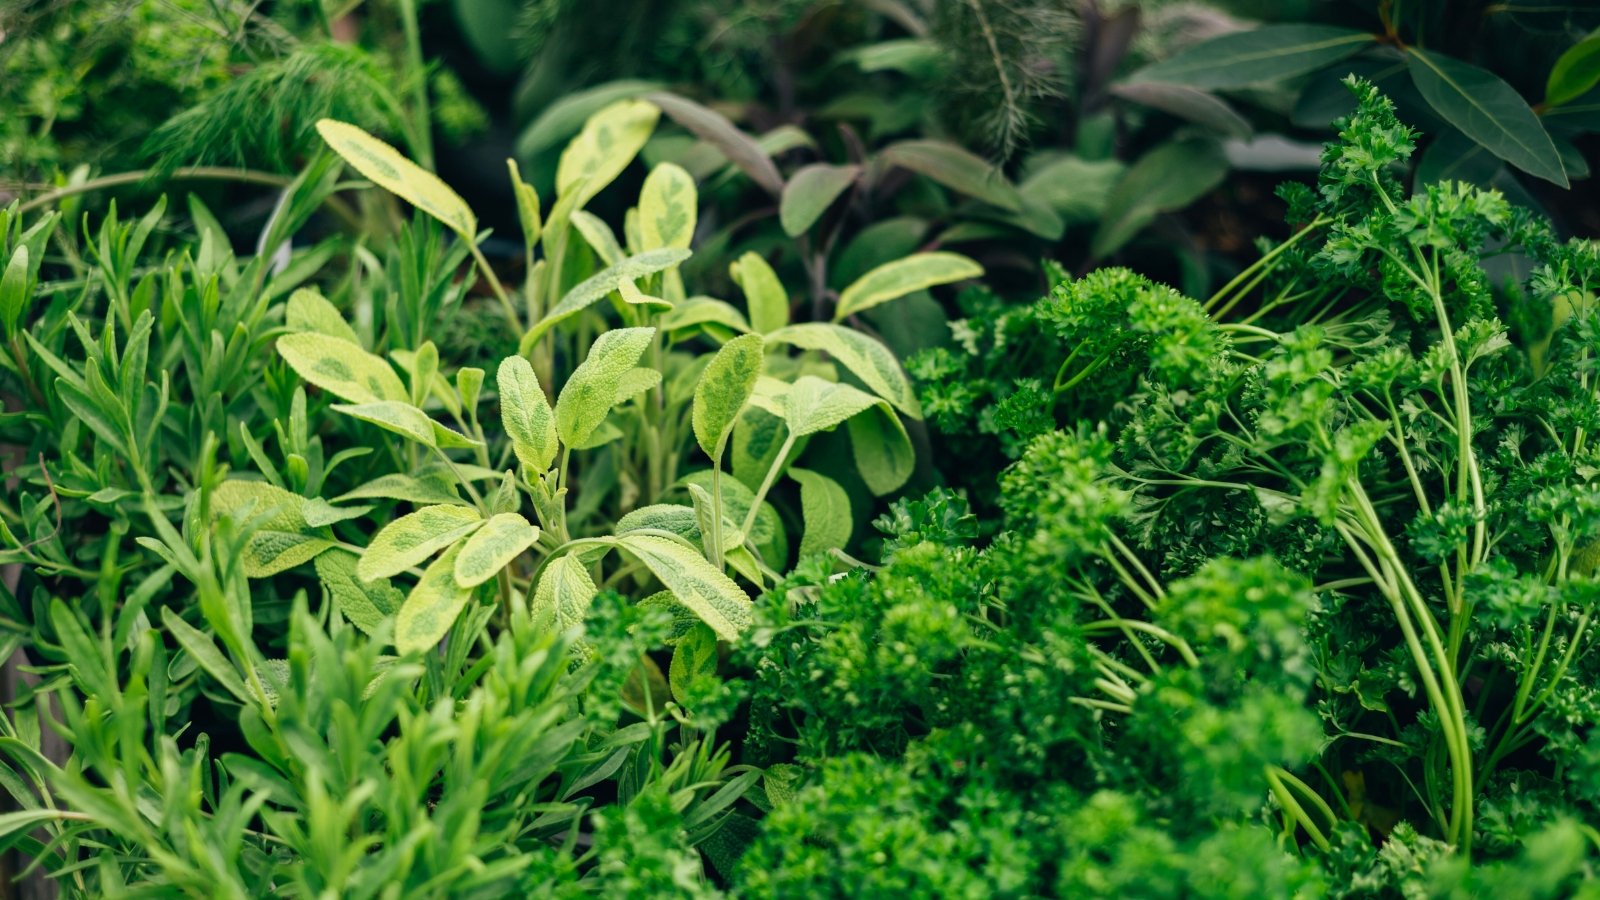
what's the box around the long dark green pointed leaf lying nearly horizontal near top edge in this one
[1133,24,1376,88]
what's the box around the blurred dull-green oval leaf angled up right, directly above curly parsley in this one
[1090,141,1227,258]
